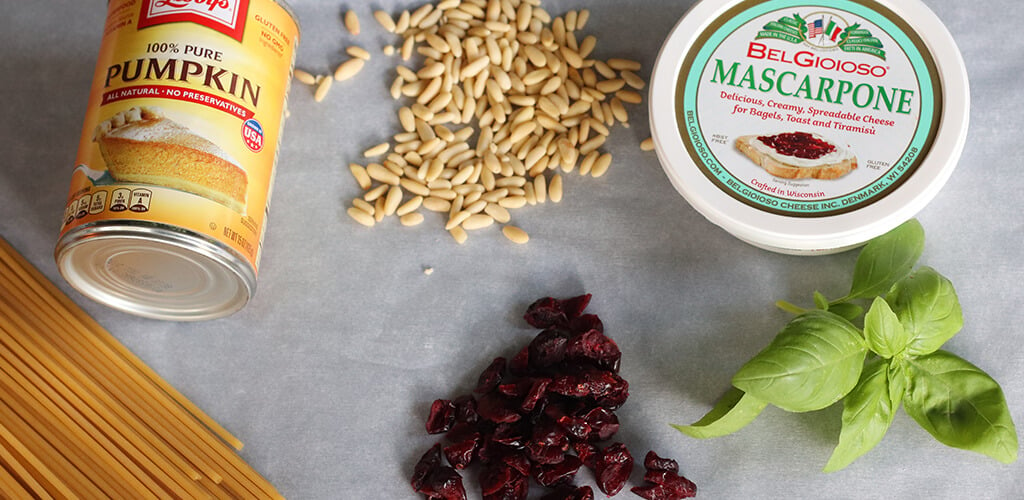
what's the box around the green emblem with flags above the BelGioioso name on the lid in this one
[755,11,886,60]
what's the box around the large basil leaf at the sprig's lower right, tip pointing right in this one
[903,350,1017,463]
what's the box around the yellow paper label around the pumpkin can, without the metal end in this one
[61,0,299,270]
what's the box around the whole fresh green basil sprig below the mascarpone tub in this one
[674,220,1018,472]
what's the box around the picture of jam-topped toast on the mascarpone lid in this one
[736,132,857,179]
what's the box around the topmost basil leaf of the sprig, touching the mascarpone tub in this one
[846,219,925,299]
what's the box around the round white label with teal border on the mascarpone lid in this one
[676,0,941,217]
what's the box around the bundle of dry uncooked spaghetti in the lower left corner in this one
[0,238,283,499]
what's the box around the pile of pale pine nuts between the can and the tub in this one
[314,0,644,244]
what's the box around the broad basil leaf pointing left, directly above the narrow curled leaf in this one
[732,310,867,412]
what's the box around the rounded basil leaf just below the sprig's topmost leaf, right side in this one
[886,267,964,356]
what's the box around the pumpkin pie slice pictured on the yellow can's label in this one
[93,107,248,213]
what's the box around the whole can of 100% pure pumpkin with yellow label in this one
[55,0,299,321]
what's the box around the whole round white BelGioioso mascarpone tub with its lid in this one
[649,0,970,254]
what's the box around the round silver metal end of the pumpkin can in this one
[56,225,255,321]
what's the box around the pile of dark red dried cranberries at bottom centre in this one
[412,294,696,500]
